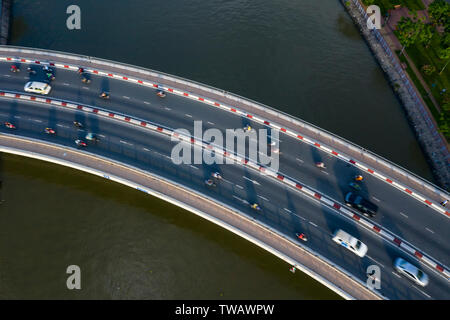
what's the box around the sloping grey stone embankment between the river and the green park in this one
[341,0,450,190]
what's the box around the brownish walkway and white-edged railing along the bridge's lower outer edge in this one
[0,133,388,300]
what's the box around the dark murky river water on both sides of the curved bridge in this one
[0,0,432,299]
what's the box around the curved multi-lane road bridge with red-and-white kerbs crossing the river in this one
[0,46,450,299]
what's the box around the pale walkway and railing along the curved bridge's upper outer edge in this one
[0,44,448,197]
